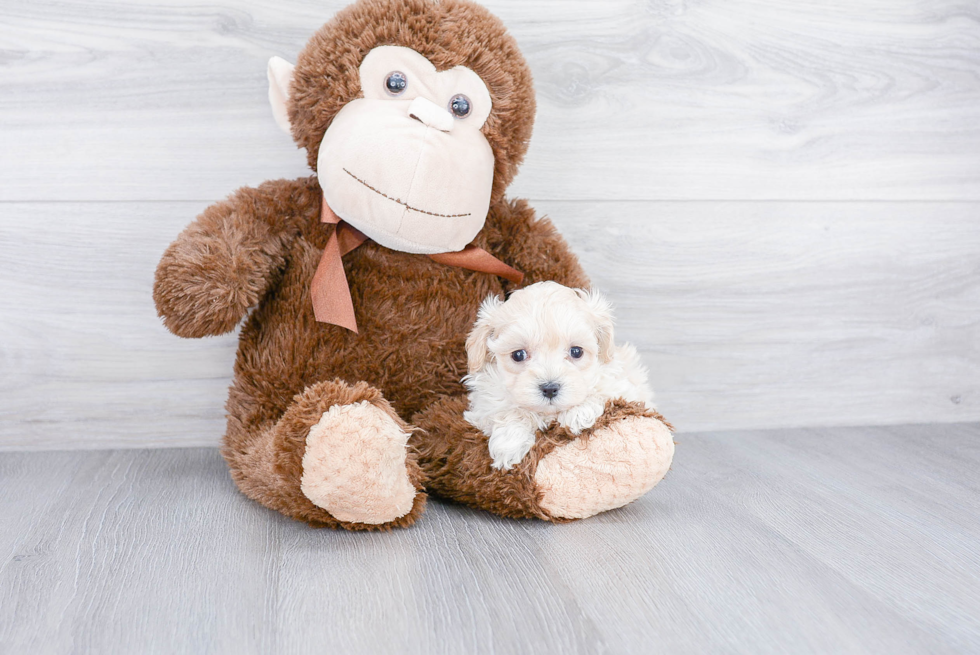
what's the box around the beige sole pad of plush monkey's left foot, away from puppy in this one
[300,401,415,525]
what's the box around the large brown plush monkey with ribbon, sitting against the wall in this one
[154,0,673,530]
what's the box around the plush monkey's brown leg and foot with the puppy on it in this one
[412,396,674,521]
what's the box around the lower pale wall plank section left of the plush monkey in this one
[0,203,237,449]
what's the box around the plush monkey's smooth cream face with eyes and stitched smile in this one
[317,46,494,254]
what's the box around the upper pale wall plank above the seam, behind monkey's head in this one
[0,0,980,200]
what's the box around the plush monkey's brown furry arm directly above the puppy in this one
[487,200,589,288]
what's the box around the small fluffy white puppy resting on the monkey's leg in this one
[463,282,653,469]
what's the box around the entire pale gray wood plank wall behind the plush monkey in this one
[0,0,980,449]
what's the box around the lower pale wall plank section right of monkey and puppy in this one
[537,202,980,430]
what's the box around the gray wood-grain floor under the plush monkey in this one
[0,424,980,654]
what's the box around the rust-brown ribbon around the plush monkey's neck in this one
[310,199,524,332]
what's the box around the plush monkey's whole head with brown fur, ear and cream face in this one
[269,0,535,254]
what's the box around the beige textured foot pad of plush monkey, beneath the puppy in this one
[534,416,674,519]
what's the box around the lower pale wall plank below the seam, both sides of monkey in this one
[0,202,980,449]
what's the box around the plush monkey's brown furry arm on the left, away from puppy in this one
[153,179,319,337]
